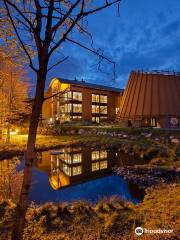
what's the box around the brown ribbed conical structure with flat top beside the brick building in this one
[118,71,180,128]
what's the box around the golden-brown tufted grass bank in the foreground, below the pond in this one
[0,184,180,240]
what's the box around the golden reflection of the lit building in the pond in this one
[37,148,115,190]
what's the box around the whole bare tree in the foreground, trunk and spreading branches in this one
[1,0,121,239]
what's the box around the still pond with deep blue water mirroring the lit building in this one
[1,147,144,203]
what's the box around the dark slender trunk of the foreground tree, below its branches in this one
[12,67,47,240]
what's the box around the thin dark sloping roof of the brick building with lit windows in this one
[56,78,124,93]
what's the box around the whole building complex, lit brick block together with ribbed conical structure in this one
[42,71,180,128]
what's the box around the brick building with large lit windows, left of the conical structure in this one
[42,78,123,123]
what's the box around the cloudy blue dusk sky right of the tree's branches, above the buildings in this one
[28,0,180,91]
